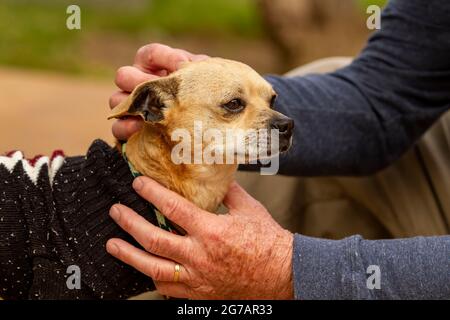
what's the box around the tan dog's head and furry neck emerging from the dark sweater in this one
[109,58,293,212]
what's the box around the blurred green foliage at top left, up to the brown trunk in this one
[0,0,386,75]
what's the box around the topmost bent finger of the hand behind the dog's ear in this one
[134,43,192,73]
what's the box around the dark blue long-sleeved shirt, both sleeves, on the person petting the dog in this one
[266,0,450,299]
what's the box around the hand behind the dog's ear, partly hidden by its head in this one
[109,43,208,140]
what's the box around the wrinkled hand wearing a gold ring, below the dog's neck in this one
[107,177,293,299]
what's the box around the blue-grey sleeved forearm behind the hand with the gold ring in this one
[293,235,450,299]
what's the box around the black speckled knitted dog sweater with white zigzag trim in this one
[0,140,156,299]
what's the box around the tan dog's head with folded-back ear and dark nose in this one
[110,58,294,162]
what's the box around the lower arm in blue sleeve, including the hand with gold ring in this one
[102,177,450,299]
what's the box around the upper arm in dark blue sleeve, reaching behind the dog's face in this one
[266,0,450,176]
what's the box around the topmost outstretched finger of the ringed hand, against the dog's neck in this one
[133,177,215,233]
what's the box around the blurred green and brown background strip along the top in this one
[0,0,385,77]
